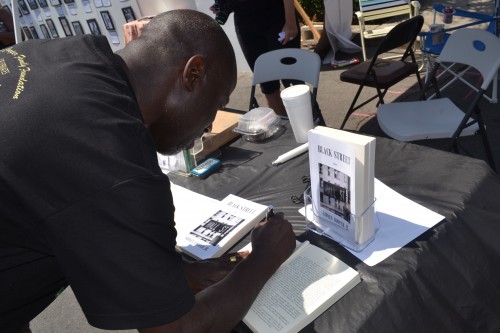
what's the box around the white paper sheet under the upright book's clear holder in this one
[299,179,444,266]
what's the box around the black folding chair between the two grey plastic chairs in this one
[340,15,424,129]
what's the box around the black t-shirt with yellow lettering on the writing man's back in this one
[0,35,194,329]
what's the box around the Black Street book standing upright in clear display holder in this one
[308,126,375,250]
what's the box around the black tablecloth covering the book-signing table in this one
[170,125,500,332]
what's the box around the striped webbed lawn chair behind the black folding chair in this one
[355,0,420,61]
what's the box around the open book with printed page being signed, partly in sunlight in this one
[243,241,361,333]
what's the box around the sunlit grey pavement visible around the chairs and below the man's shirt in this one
[31,0,500,333]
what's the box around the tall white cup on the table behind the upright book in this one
[281,84,314,143]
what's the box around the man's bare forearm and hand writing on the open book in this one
[139,213,295,333]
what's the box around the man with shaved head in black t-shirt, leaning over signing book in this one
[0,10,295,333]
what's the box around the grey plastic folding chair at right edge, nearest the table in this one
[377,29,500,169]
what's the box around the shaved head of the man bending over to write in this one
[117,9,236,154]
